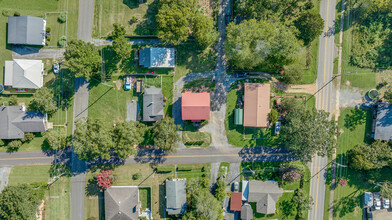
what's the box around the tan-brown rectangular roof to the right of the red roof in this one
[244,83,271,127]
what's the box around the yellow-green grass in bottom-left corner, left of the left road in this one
[8,165,70,220]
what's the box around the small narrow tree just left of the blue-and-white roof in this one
[110,23,132,60]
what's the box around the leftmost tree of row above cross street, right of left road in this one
[73,119,112,160]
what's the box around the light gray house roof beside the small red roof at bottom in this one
[248,180,283,214]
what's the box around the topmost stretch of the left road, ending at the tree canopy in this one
[78,0,94,42]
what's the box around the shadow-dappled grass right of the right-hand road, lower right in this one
[333,108,392,220]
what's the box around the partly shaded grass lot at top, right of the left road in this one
[93,0,158,38]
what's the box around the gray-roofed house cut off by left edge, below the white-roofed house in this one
[0,106,49,139]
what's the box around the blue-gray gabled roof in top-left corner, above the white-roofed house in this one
[7,16,46,46]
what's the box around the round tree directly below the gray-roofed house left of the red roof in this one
[154,117,180,152]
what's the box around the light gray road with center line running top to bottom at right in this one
[309,0,336,220]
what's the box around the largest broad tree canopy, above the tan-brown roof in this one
[225,19,300,69]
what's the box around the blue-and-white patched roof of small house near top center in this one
[139,47,176,68]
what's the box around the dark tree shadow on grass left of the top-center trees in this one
[135,0,159,35]
